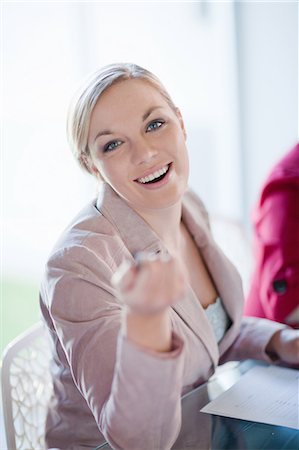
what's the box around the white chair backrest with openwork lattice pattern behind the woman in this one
[1,323,52,450]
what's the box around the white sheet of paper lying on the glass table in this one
[201,366,299,430]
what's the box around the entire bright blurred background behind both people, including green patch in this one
[1,1,298,353]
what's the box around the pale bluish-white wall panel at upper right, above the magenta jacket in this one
[235,1,298,230]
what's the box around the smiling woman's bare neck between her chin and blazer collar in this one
[138,201,182,256]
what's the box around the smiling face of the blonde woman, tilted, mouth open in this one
[88,79,189,212]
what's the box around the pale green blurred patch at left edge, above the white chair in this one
[0,279,40,359]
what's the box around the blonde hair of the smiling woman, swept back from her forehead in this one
[67,63,176,174]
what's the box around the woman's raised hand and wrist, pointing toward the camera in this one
[112,253,187,352]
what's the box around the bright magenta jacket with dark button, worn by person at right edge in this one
[245,144,299,328]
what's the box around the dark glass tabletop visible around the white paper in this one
[97,361,299,450]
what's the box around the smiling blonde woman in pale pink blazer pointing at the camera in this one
[41,64,299,450]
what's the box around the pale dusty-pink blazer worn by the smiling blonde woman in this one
[41,185,281,450]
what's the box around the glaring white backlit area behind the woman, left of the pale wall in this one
[2,1,240,282]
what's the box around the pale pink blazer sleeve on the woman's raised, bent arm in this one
[43,246,183,450]
